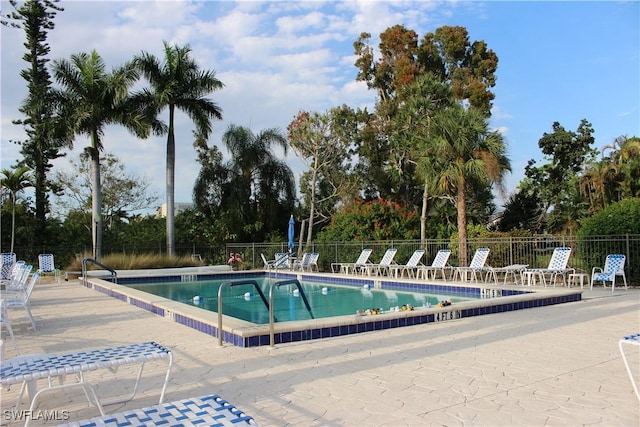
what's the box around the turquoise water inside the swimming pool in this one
[127,278,479,324]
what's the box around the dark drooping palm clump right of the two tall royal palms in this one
[222,125,295,242]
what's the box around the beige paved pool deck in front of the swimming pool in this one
[1,279,640,427]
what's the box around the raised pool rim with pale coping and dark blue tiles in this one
[79,271,582,348]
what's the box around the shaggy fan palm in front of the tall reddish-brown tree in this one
[432,104,511,265]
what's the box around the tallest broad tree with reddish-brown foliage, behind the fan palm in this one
[354,25,498,208]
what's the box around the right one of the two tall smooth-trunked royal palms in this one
[135,42,224,255]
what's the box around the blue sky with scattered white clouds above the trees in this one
[0,0,640,213]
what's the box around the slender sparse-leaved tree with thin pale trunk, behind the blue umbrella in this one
[287,106,357,246]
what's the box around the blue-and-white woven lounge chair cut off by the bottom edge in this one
[60,394,257,427]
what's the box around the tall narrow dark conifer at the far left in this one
[2,0,65,241]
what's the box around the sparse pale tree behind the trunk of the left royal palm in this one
[55,153,158,228]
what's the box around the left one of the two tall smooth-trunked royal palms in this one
[53,50,162,258]
